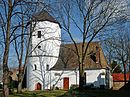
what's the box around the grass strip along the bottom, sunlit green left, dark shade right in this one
[9,89,130,97]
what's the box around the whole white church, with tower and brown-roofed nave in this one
[26,12,112,91]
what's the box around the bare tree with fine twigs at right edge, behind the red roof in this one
[103,23,130,83]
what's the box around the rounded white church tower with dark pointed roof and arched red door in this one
[27,11,61,91]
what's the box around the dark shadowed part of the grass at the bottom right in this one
[58,88,130,97]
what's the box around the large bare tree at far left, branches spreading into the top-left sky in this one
[0,0,49,97]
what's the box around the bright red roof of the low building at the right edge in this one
[112,73,130,82]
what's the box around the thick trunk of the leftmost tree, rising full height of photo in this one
[3,0,12,97]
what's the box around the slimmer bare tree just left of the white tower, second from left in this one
[13,0,51,93]
